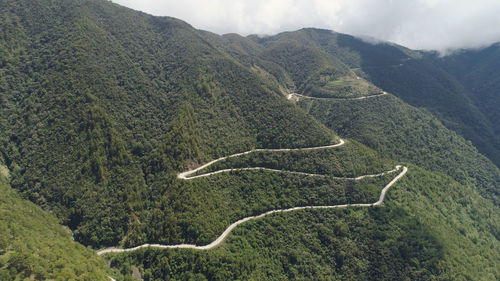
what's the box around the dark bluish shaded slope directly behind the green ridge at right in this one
[367,57,500,166]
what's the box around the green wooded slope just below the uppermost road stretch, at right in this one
[299,95,500,205]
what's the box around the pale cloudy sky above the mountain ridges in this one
[113,0,500,52]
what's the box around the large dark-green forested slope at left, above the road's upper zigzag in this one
[1,1,336,245]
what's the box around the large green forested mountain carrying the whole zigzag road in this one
[0,0,500,280]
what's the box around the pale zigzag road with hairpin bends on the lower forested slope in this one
[97,137,408,255]
